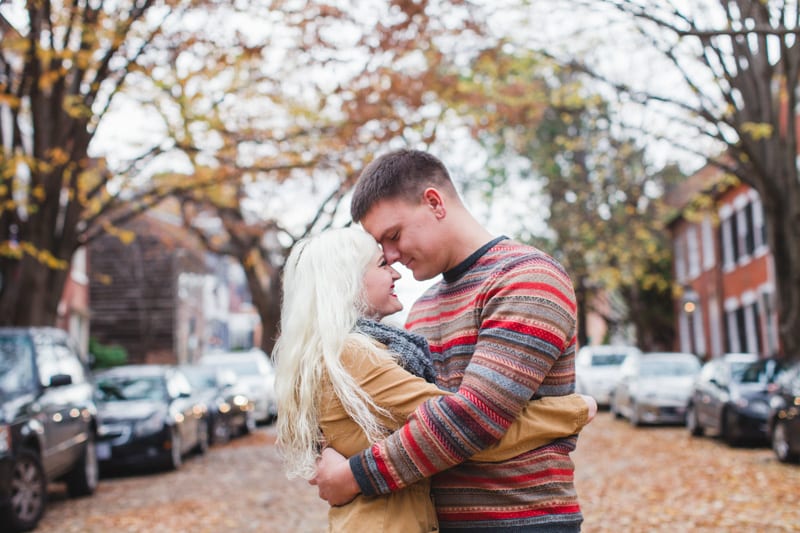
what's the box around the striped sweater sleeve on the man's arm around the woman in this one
[350,262,576,496]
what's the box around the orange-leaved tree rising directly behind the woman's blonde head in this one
[141,0,500,352]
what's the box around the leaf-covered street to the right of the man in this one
[573,412,800,533]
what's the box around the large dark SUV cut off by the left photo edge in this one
[0,328,98,531]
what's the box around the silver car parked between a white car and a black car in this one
[611,352,700,426]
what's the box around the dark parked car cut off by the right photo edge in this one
[767,363,800,463]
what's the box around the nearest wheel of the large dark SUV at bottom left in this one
[1,449,47,531]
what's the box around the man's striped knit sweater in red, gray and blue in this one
[350,237,582,531]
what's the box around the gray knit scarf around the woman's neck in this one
[356,318,436,383]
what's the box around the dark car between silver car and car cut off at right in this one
[686,353,780,444]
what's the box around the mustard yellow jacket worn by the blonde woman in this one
[319,340,588,533]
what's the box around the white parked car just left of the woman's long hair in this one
[198,348,278,423]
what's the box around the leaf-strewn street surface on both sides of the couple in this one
[37,412,800,533]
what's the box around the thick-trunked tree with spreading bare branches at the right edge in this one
[561,0,800,359]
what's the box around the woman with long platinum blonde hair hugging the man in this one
[275,227,589,532]
